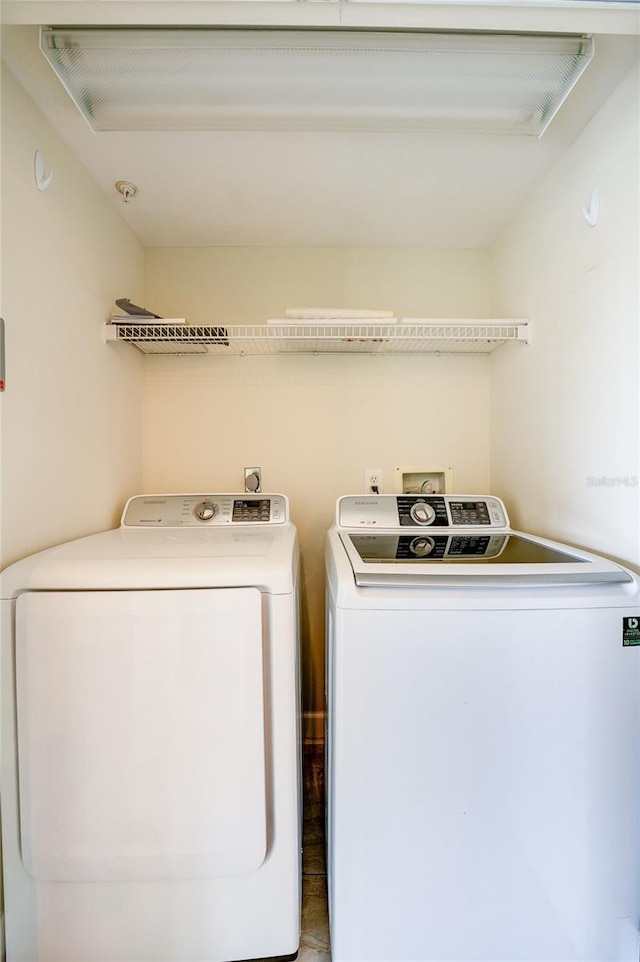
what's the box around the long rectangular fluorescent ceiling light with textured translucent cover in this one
[40,28,593,136]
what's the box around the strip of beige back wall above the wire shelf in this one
[145,247,489,324]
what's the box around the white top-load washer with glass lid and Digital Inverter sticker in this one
[326,495,640,962]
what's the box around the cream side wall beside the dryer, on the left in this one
[0,70,143,566]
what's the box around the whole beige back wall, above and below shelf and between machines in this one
[144,248,489,711]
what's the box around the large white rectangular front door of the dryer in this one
[16,588,267,881]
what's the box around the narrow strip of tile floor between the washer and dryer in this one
[298,742,331,962]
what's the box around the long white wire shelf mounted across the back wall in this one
[105,319,529,356]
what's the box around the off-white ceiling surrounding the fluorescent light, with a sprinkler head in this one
[2,0,640,248]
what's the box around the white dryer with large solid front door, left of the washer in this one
[2,494,301,962]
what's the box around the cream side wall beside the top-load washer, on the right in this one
[491,65,640,564]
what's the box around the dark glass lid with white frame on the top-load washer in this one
[338,528,633,586]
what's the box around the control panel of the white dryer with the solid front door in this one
[120,494,289,528]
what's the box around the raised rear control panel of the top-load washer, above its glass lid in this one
[336,494,509,528]
